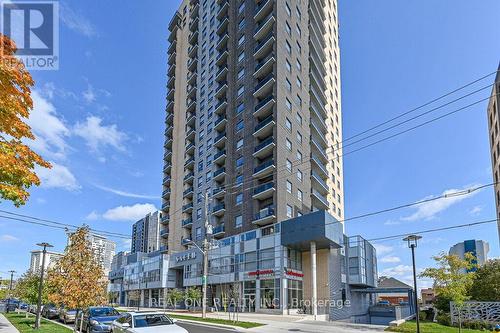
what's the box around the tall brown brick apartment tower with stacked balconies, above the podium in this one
[162,0,344,251]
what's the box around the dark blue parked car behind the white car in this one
[75,306,120,333]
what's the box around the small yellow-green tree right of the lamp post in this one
[420,253,477,330]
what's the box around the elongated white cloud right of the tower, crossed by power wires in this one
[402,185,479,221]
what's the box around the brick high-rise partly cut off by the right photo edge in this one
[488,64,500,242]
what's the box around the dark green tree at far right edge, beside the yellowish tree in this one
[470,259,500,302]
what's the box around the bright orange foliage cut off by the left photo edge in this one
[0,33,51,206]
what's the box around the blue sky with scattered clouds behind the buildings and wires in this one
[0,0,500,284]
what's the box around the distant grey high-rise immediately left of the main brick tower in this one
[131,211,161,253]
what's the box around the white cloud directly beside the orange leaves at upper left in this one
[26,88,70,159]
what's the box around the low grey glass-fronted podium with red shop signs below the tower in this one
[109,211,377,322]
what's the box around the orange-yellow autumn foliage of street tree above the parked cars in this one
[47,227,107,309]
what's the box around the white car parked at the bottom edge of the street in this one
[111,311,188,333]
